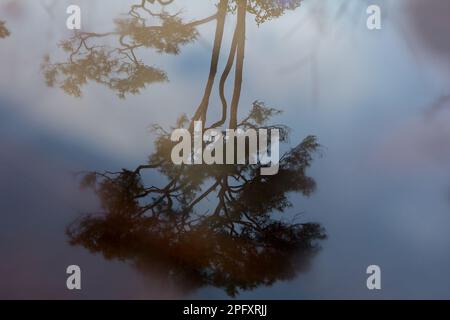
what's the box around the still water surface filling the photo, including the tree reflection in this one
[0,0,450,299]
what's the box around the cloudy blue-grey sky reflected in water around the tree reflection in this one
[0,0,450,298]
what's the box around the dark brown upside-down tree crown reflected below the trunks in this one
[68,102,325,296]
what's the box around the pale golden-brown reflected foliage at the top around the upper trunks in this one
[42,0,301,98]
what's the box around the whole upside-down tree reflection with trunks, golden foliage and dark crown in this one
[43,0,325,296]
